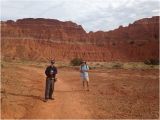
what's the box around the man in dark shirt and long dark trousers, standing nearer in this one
[44,60,57,102]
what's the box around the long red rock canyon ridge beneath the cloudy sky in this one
[1,16,159,61]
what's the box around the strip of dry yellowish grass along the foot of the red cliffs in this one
[1,60,159,69]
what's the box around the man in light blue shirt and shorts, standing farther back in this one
[80,61,89,91]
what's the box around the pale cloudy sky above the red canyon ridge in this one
[0,0,160,32]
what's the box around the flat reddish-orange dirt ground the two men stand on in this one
[1,64,159,119]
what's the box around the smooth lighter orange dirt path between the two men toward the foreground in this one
[24,75,90,118]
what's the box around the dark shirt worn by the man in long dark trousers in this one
[45,66,57,78]
